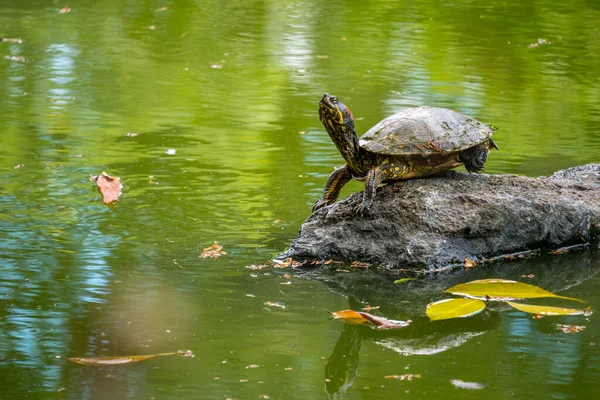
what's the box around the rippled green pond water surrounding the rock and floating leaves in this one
[0,0,600,399]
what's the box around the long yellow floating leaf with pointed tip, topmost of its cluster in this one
[444,279,585,303]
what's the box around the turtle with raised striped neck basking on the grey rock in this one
[313,93,498,215]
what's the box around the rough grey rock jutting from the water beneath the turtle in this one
[283,164,600,270]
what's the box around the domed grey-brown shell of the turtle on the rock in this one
[360,107,495,155]
